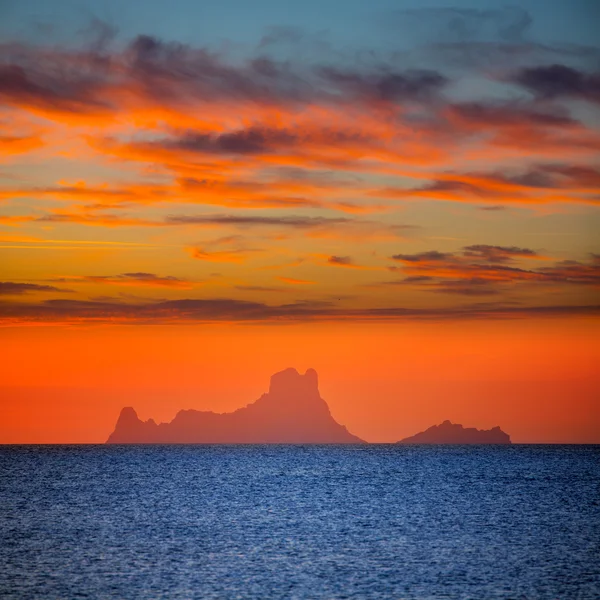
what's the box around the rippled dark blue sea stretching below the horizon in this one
[0,445,600,600]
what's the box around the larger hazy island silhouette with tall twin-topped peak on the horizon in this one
[107,369,365,444]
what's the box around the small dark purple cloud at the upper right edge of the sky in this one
[513,64,600,103]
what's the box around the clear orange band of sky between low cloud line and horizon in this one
[0,318,600,443]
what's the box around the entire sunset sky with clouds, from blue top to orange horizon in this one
[0,0,600,443]
